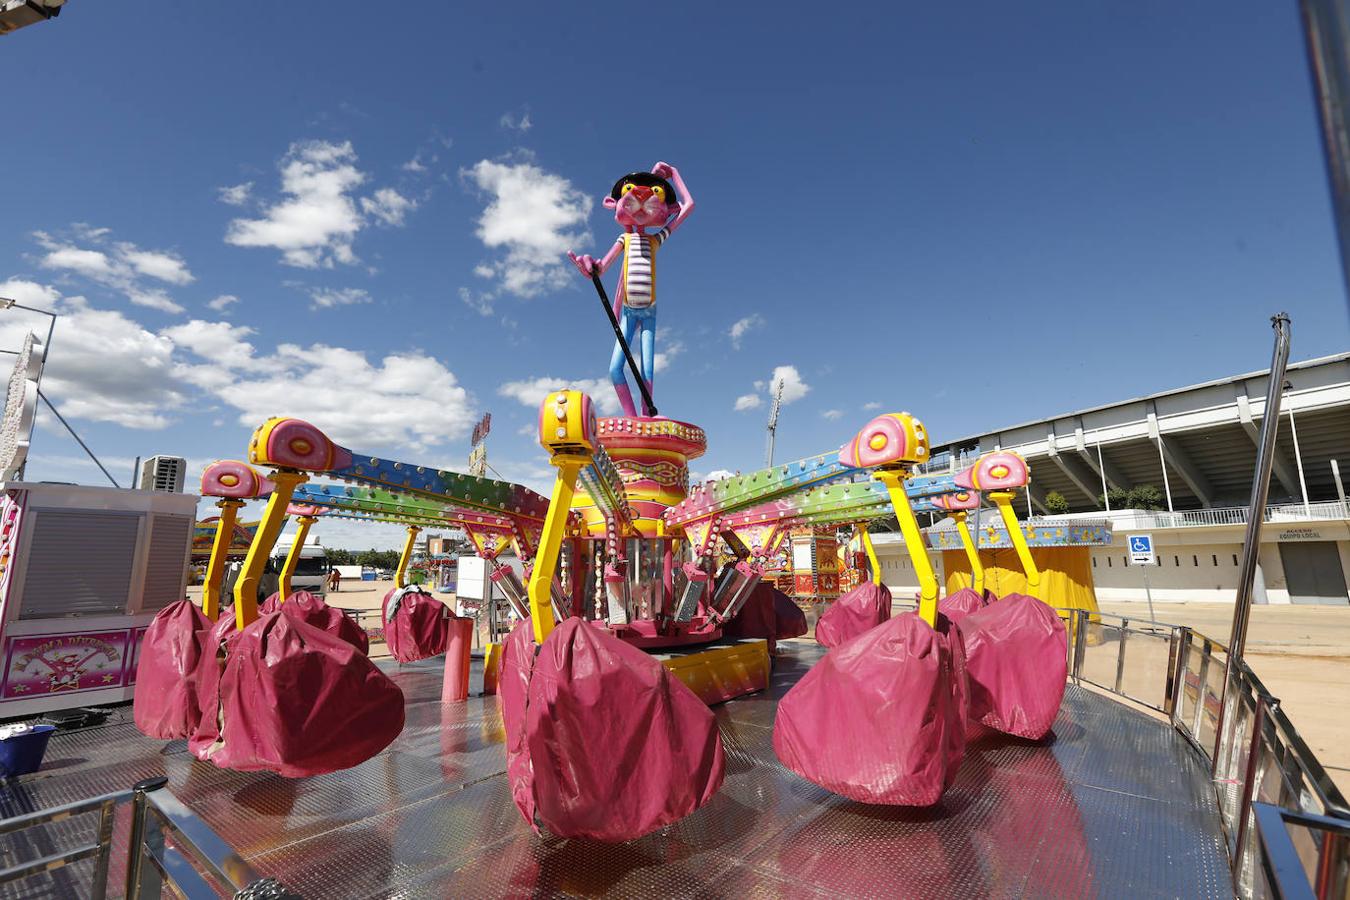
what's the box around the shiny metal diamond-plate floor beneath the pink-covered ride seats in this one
[0,641,1233,899]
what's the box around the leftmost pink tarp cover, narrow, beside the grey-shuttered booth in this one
[131,600,212,741]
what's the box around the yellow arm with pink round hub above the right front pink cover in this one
[840,413,937,626]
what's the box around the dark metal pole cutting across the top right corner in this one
[1299,0,1350,299]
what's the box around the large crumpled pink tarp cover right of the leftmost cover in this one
[188,600,404,777]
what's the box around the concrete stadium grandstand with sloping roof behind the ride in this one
[878,354,1350,604]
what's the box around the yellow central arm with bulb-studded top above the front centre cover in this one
[525,390,599,644]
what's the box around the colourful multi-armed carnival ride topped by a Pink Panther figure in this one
[116,163,1112,841]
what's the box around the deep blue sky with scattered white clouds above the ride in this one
[0,0,1350,545]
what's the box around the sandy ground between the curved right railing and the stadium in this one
[1102,603,1350,796]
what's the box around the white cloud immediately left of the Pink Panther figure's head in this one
[460,159,591,308]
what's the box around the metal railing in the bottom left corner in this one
[0,776,294,900]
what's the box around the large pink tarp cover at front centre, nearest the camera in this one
[500,618,725,842]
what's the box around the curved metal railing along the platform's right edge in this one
[1060,610,1350,897]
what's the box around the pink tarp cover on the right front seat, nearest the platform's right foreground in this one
[774,613,967,807]
